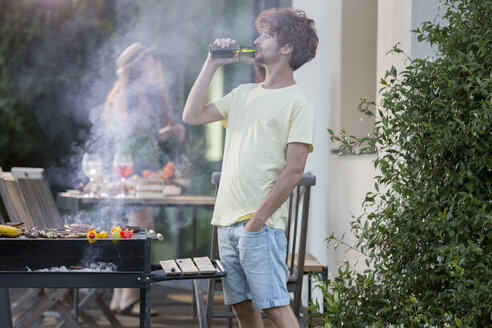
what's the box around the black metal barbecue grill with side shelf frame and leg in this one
[0,231,226,327]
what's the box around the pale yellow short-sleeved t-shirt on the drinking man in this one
[212,83,314,229]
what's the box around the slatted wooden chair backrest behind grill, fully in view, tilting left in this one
[12,167,63,228]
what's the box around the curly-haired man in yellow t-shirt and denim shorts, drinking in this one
[183,9,318,328]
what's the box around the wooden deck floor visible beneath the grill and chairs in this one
[10,283,273,328]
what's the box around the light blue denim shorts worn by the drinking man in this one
[218,221,290,309]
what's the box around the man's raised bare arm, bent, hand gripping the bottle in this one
[183,39,238,125]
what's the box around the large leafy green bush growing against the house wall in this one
[312,0,492,327]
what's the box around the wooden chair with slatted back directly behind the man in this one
[206,172,316,326]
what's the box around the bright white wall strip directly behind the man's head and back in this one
[292,0,342,272]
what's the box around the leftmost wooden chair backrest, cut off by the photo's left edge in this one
[0,168,33,227]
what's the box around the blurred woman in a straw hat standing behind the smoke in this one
[103,43,184,315]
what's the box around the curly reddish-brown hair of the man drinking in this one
[255,8,319,71]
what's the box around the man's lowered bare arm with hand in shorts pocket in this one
[244,142,309,231]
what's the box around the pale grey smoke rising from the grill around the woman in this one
[32,0,260,229]
